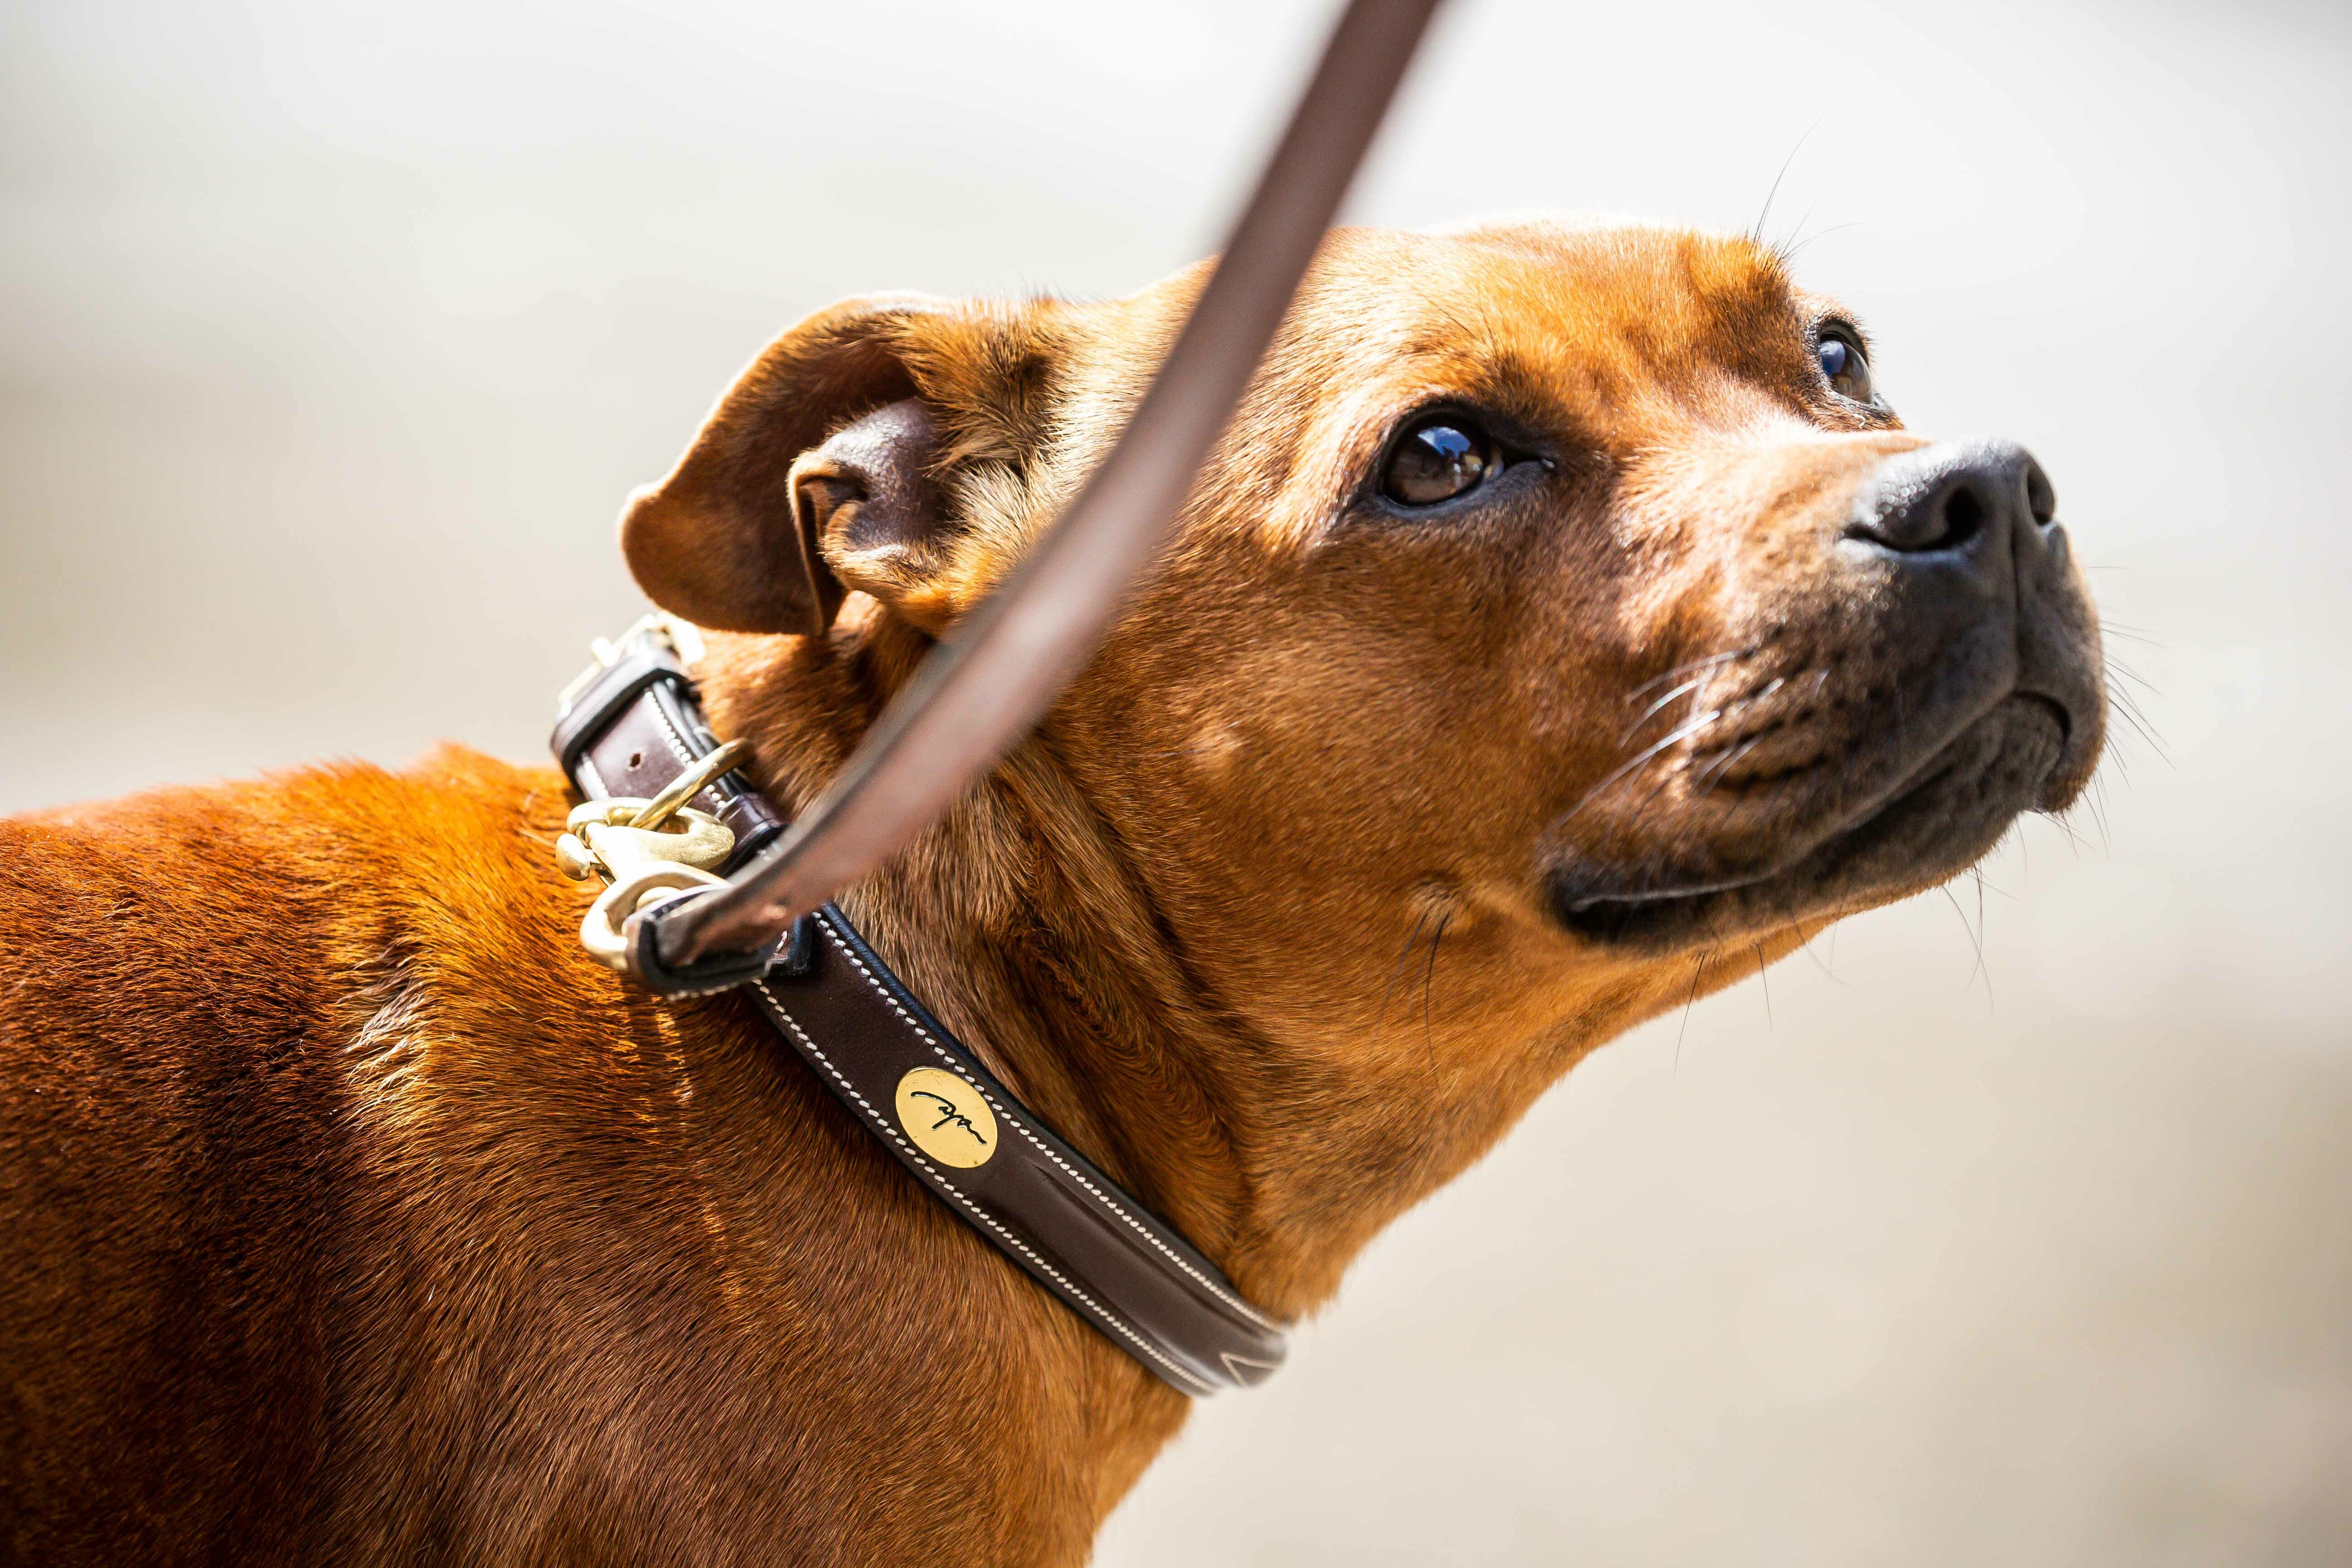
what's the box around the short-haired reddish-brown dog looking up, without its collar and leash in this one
[0,223,2102,1563]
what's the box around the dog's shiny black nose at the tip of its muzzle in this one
[1846,442,2058,555]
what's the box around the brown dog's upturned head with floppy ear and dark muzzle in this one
[623,221,2105,1067]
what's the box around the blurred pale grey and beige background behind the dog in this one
[0,0,2352,1568]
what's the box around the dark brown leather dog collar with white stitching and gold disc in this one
[553,625,1287,1394]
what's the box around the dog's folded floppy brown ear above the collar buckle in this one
[621,294,948,635]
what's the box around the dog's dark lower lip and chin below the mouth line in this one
[1548,696,2068,955]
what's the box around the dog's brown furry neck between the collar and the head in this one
[696,599,1639,1317]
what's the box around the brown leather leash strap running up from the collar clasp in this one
[626,0,1437,992]
